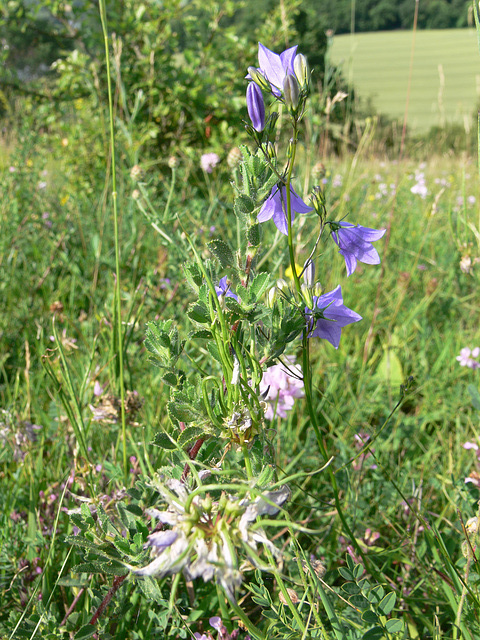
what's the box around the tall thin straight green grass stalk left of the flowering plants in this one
[99,0,128,481]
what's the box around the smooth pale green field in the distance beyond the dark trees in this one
[331,29,480,131]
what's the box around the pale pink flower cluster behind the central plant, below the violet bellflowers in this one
[260,356,305,420]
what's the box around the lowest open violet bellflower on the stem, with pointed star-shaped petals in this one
[305,285,362,349]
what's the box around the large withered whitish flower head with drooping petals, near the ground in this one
[132,478,290,604]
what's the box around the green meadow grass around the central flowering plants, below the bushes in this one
[0,53,480,638]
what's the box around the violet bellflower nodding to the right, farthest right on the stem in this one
[332,222,385,276]
